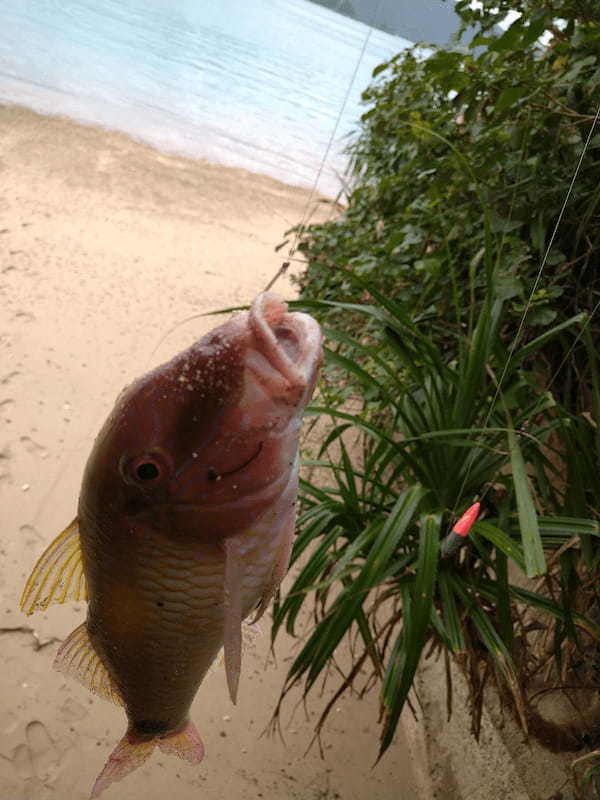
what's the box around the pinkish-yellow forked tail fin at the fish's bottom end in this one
[90,722,204,800]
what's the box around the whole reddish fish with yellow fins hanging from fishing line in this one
[21,292,322,798]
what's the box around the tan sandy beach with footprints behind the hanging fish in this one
[0,107,564,800]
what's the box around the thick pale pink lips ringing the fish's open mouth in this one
[248,292,322,388]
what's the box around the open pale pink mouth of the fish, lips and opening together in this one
[246,292,322,401]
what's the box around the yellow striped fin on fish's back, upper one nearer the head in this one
[21,518,87,615]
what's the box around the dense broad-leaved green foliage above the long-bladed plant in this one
[300,0,600,407]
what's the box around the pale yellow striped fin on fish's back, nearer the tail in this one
[54,622,123,705]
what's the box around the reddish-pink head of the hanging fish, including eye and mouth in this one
[79,293,321,539]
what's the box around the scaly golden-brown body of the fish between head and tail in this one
[88,514,289,735]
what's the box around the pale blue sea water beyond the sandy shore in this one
[0,0,409,194]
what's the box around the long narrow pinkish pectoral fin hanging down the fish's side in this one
[223,538,244,704]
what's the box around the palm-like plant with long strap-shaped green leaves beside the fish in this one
[272,276,600,756]
